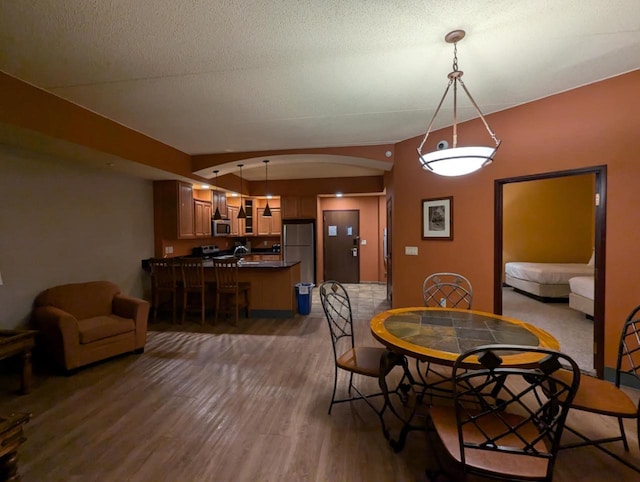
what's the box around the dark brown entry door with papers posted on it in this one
[322,210,360,283]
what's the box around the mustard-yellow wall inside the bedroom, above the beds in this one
[502,174,595,270]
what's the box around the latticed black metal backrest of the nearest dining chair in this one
[453,345,580,480]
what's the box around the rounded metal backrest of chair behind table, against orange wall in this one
[422,273,473,309]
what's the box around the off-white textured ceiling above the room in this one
[0,0,640,179]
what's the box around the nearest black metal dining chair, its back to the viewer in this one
[427,345,580,481]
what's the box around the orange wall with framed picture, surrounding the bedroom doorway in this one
[393,70,640,366]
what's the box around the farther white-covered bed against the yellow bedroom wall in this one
[505,261,594,299]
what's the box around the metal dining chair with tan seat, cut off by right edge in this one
[560,306,640,473]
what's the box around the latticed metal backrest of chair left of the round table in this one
[318,280,354,359]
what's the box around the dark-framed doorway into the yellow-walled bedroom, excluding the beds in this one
[494,166,606,377]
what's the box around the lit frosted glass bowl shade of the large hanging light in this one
[418,145,499,176]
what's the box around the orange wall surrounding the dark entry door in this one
[316,196,386,282]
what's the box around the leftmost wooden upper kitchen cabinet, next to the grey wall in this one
[153,181,195,239]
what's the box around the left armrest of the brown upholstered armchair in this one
[33,306,80,367]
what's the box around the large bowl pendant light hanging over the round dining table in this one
[418,30,501,176]
